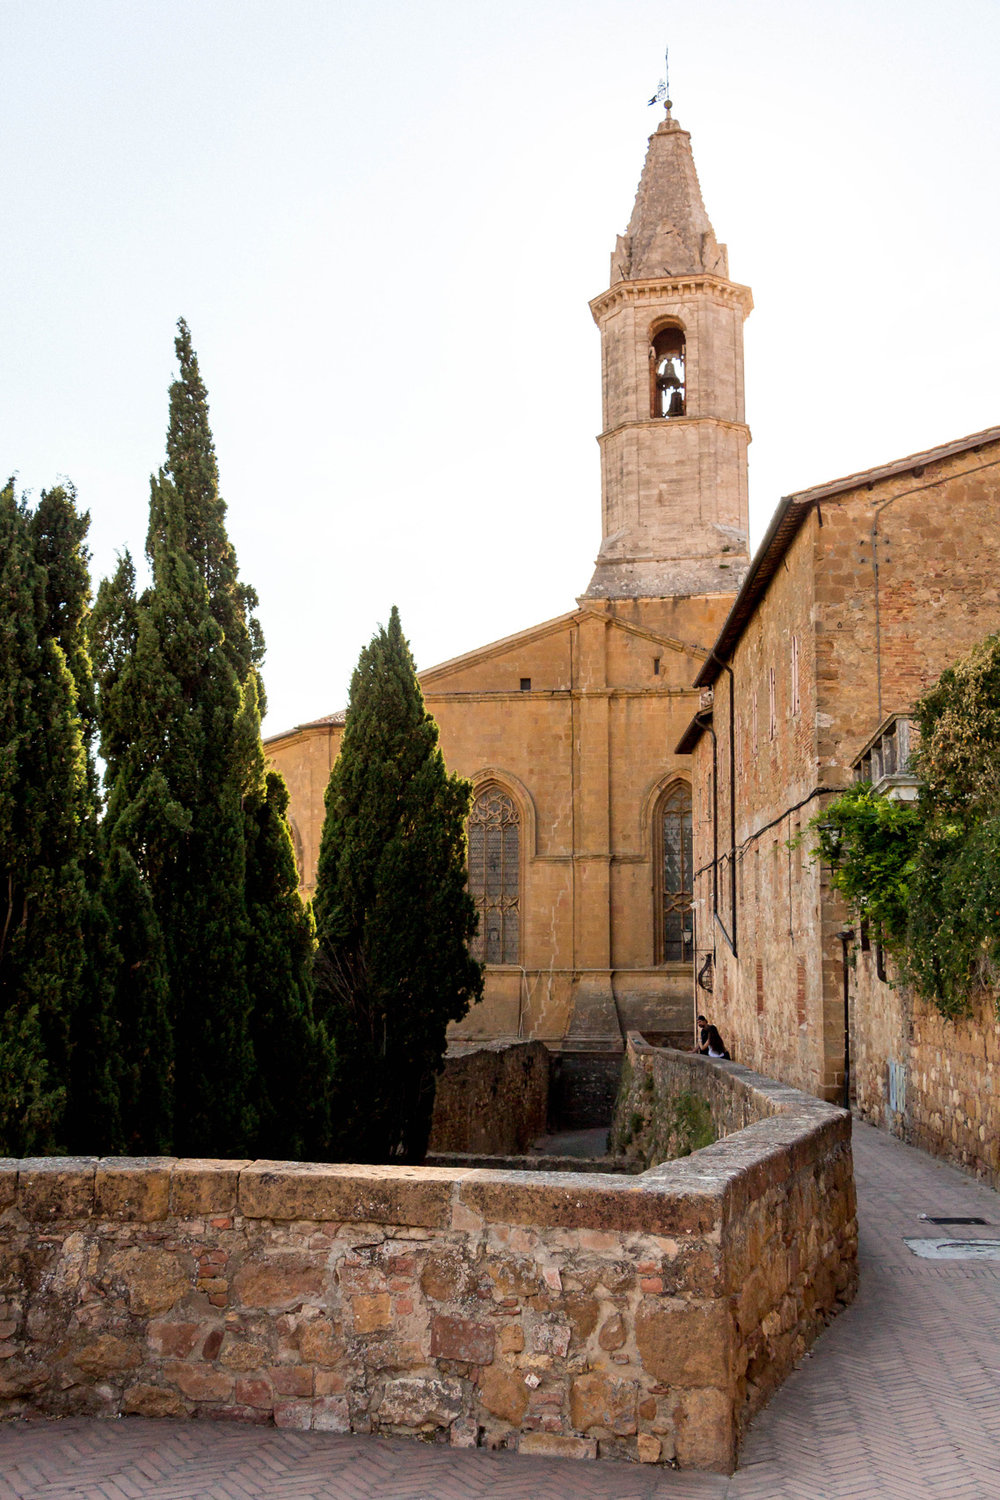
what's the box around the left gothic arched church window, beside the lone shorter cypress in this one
[469,786,520,963]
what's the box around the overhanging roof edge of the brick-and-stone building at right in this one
[685,428,1000,690]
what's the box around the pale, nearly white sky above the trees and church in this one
[0,0,1000,732]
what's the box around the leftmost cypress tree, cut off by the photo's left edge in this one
[0,482,88,1155]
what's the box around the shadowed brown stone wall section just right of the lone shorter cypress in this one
[427,1041,549,1157]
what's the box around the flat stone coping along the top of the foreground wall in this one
[0,1034,850,1235]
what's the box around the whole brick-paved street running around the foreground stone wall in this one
[0,1124,1000,1500]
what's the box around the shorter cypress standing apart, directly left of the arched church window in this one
[313,608,483,1161]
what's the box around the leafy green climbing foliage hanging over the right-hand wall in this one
[810,636,1000,1016]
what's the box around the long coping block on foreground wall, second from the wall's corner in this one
[240,1161,466,1229]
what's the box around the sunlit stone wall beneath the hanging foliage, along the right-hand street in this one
[850,951,1000,1188]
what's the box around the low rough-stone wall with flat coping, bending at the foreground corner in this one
[0,1064,855,1470]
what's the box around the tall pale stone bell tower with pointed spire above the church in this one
[583,101,753,600]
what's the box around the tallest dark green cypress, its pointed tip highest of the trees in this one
[99,320,327,1155]
